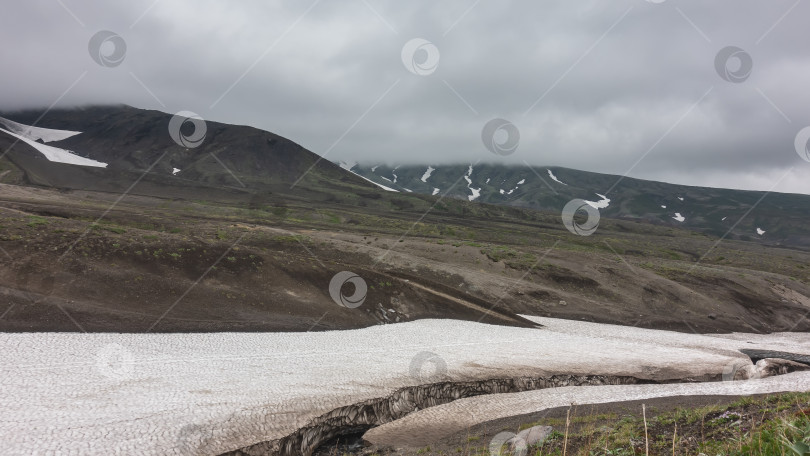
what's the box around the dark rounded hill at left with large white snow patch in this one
[0,105,382,205]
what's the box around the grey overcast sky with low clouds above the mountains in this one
[0,0,810,194]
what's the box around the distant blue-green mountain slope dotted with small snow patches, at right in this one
[343,164,810,247]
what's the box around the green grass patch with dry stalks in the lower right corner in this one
[446,393,810,456]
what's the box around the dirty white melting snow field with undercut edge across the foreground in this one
[0,317,810,455]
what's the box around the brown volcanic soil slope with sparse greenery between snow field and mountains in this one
[0,184,810,332]
